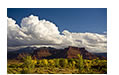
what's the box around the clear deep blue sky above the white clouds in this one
[7,8,107,33]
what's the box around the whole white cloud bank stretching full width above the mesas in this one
[7,15,107,52]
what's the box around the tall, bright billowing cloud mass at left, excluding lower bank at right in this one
[7,15,60,46]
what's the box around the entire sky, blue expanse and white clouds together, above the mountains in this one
[7,8,107,53]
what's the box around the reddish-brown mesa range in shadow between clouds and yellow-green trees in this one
[8,46,106,59]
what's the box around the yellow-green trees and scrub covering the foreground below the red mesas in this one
[7,54,107,74]
